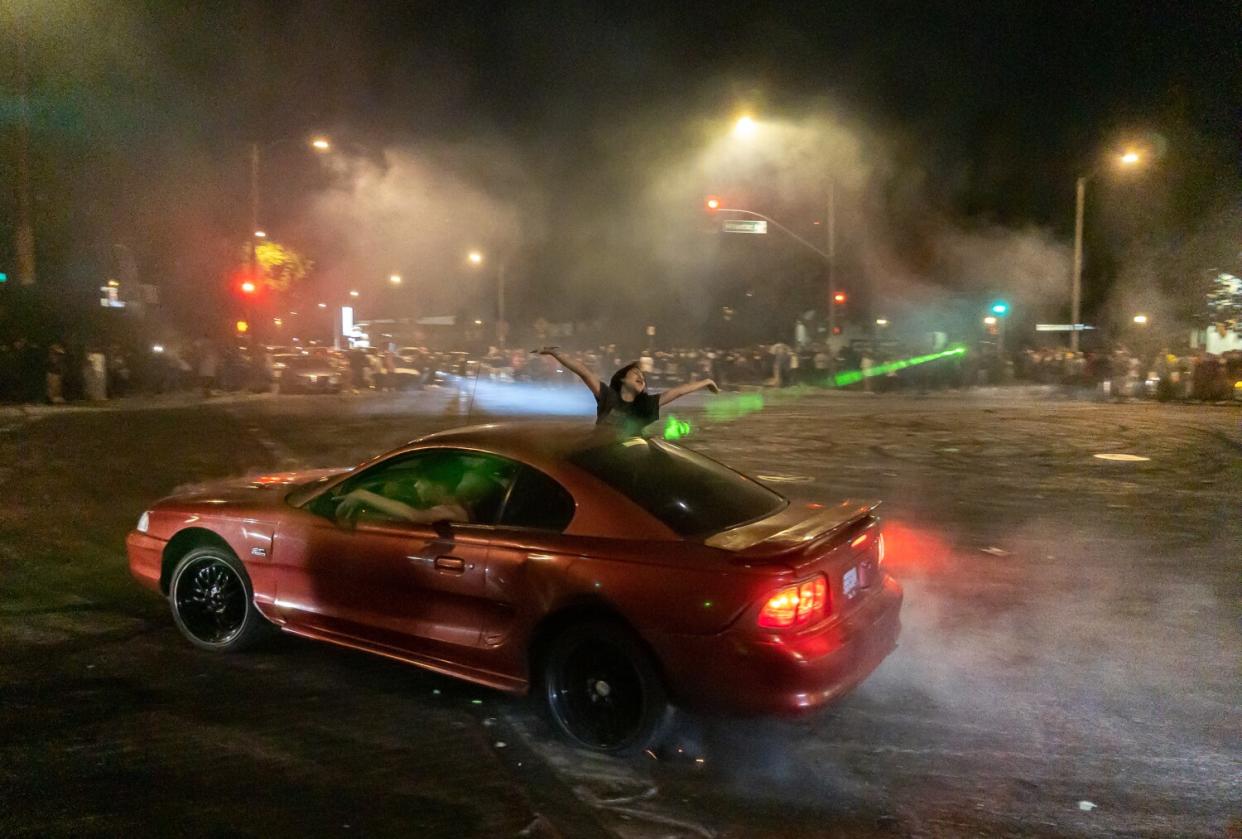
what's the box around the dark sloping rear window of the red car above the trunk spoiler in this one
[570,437,786,537]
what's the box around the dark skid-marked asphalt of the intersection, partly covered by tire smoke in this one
[0,388,1242,838]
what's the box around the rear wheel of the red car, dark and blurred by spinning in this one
[539,622,671,756]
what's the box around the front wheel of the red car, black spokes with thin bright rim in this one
[168,545,271,653]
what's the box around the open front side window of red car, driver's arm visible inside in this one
[313,449,517,524]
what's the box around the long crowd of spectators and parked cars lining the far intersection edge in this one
[0,338,1242,403]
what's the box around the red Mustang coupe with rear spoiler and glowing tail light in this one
[127,422,902,753]
